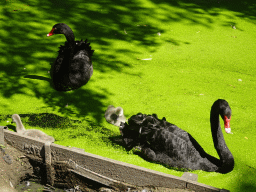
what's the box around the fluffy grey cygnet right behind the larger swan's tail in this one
[105,105,126,127]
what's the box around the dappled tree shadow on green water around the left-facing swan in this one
[0,0,256,122]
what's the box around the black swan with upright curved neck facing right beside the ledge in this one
[117,99,234,173]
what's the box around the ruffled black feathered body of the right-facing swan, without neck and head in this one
[120,113,219,171]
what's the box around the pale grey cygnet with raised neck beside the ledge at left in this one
[12,114,55,143]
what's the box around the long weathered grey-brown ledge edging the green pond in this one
[0,129,228,192]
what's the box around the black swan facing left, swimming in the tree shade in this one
[47,23,94,91]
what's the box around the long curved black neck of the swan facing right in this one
[210,100,234,173]
